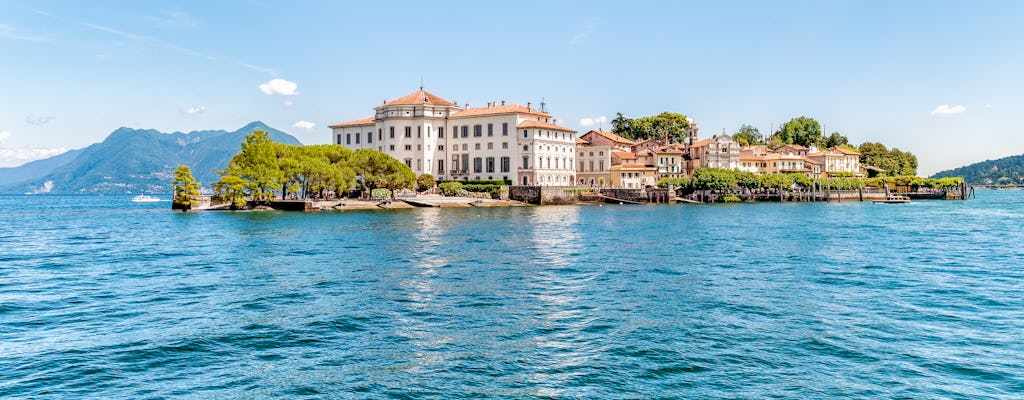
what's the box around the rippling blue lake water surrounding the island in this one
[0,191,1024,399]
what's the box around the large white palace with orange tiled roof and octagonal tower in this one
[330,88,575,186]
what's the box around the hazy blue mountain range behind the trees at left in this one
[0,121,302,194]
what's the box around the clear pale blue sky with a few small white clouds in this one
[0,0,1024,175]
